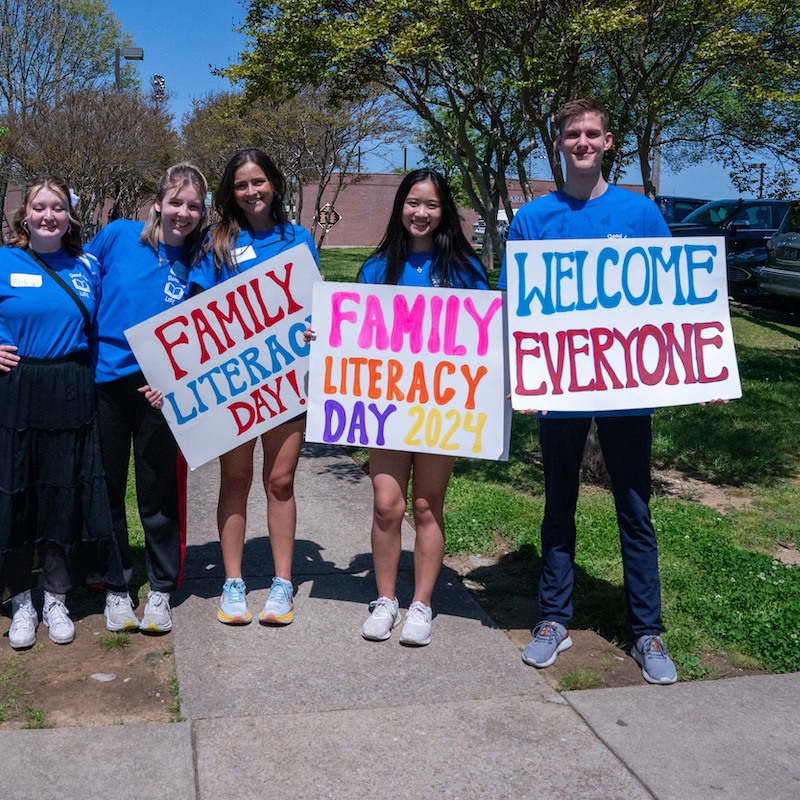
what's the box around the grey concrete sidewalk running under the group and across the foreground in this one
[0,445,800,800]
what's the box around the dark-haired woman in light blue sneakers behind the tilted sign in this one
[191,149,318,625]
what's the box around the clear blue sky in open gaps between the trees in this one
[109,0,737,199]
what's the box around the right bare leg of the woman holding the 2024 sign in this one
[411,453,456,606]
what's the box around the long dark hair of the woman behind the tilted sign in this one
[206,148,289,270]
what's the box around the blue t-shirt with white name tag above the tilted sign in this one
[189,222,319,293]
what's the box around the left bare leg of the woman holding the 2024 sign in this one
[369,450,412,600]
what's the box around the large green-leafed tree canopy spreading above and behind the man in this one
[226,0,800,260]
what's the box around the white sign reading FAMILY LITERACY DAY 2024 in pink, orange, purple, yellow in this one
[306,283,510,459]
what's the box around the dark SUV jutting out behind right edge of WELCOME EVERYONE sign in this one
[669,199,789,300]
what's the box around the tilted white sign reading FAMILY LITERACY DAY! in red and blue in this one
[125,244,320,469]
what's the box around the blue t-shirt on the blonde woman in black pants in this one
[87,219,191,384]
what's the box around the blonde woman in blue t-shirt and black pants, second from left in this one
[88,164,208,634]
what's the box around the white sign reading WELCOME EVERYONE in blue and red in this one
[506,237,742,411]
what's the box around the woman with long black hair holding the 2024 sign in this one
[358,169,488,646]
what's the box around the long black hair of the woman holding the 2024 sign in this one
[362,168,486,288]
